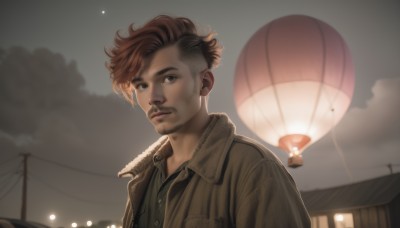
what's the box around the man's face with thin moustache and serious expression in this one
[132,45,207,135]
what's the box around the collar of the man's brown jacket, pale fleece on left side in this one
[118,113,235,183]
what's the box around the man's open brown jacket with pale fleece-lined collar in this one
[119,114,310,228]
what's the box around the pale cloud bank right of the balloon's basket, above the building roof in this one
[294,78,400,188]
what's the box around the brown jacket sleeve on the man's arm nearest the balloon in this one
[236,159,311,228]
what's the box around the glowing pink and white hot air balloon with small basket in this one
[234,15,354,167]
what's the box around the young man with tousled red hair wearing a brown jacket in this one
[107,16,310,228]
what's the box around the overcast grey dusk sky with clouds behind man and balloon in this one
[0,0,400,226]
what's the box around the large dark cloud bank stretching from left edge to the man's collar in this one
[0,47,155,161]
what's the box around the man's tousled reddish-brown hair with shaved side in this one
[106,15,222,105]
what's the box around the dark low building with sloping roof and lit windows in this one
[301,173,400,228]
